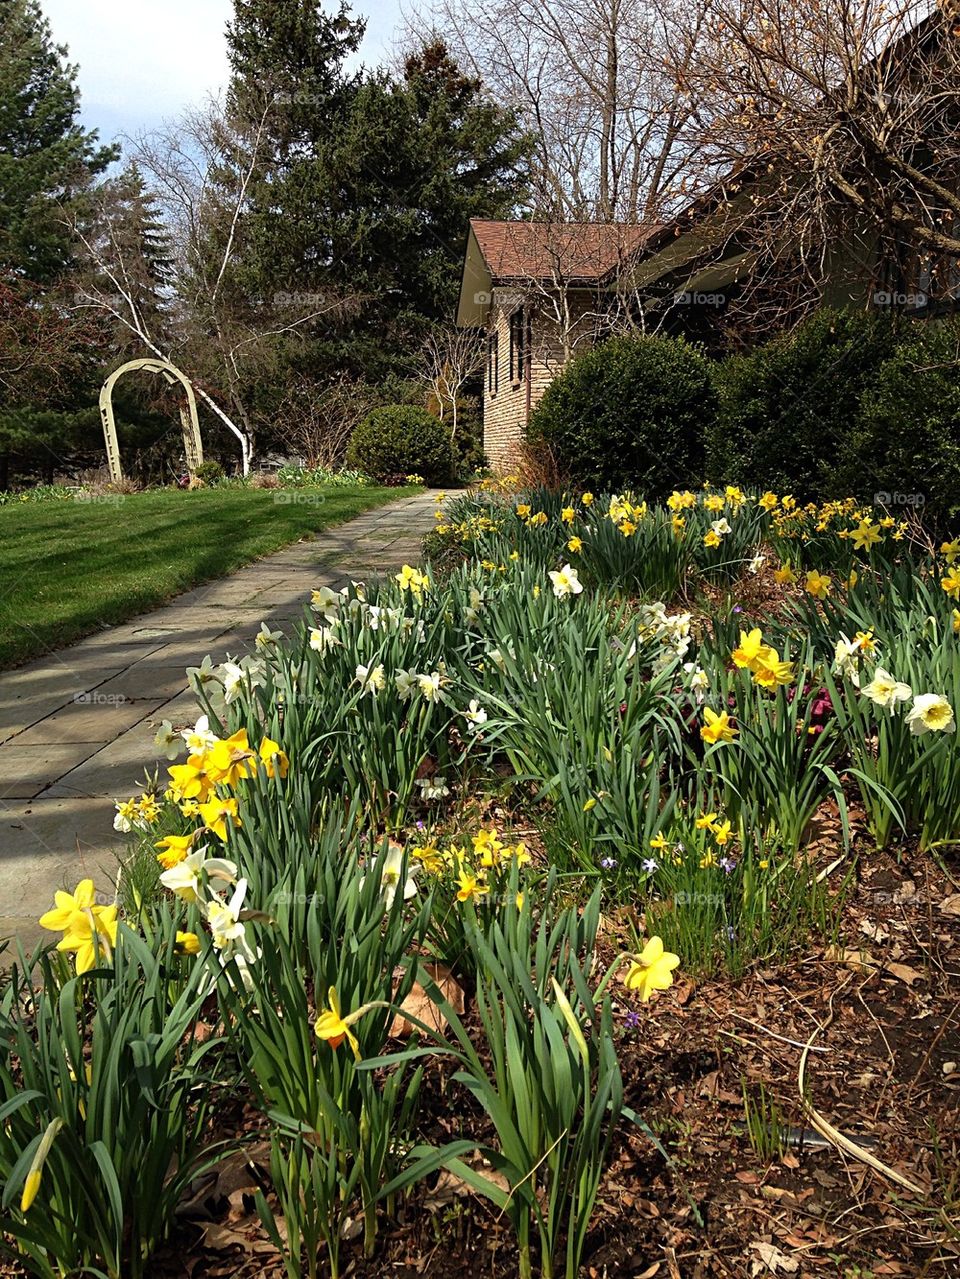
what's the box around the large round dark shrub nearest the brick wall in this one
[528,338,716,500]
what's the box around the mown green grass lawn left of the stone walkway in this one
[0,487,410,669]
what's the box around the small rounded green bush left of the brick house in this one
[346,404,454,485]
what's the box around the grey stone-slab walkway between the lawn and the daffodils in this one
[0,492,436,944]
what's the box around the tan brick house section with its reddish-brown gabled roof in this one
[456,219,657,471]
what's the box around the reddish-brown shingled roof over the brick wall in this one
[470,217,660,283]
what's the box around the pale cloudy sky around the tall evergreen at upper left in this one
[41,0,400,142]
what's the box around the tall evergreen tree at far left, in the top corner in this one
[0,0,118,283]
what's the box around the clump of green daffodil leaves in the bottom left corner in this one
[0,911,224,1279]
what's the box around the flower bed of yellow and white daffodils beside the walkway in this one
[0,485,960,1279]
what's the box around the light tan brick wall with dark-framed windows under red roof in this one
[483,290,597,473]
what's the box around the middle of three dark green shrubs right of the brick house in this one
[704,310,900,501]
